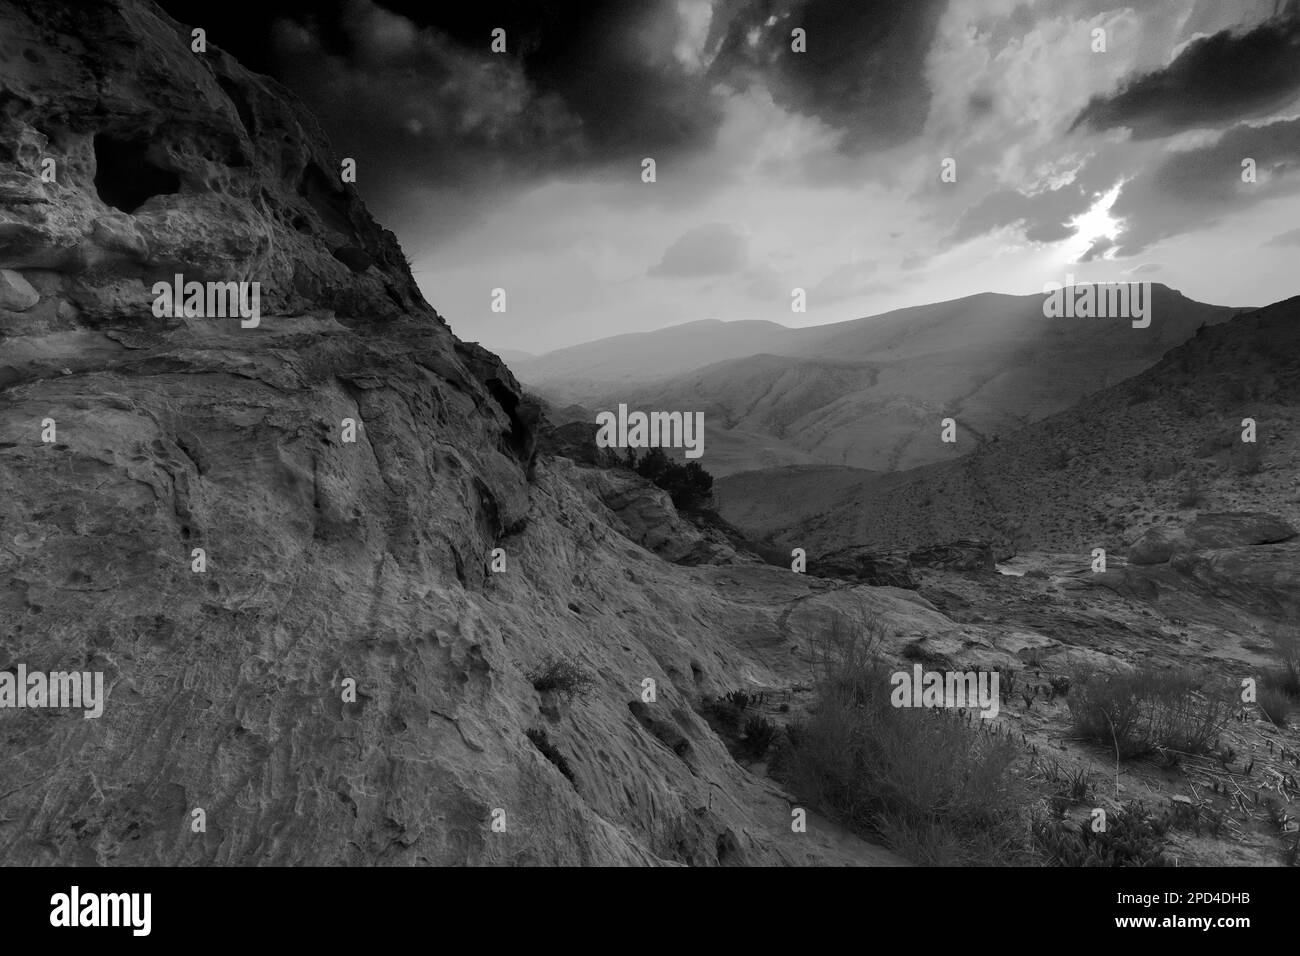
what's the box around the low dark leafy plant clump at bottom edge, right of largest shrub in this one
[1032,801,1169,866]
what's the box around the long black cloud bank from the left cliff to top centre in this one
[164,0,946,225]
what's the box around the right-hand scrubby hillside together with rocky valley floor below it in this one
[718,274,1300,865]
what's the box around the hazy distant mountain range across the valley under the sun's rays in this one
[515,285,1242,475]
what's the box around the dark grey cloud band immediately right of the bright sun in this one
[1110,120,1300,256]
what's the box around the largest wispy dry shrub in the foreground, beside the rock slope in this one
[771,620,1028,865]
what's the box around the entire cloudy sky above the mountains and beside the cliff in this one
[163,0,1300,352]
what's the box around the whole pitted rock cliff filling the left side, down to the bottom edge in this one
[0,0,915,865]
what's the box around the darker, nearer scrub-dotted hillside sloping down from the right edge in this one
[715,297,1300,554]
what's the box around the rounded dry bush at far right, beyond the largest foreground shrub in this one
[1069,667,1232,758]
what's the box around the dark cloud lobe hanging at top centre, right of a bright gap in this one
[710,0,948,152]
